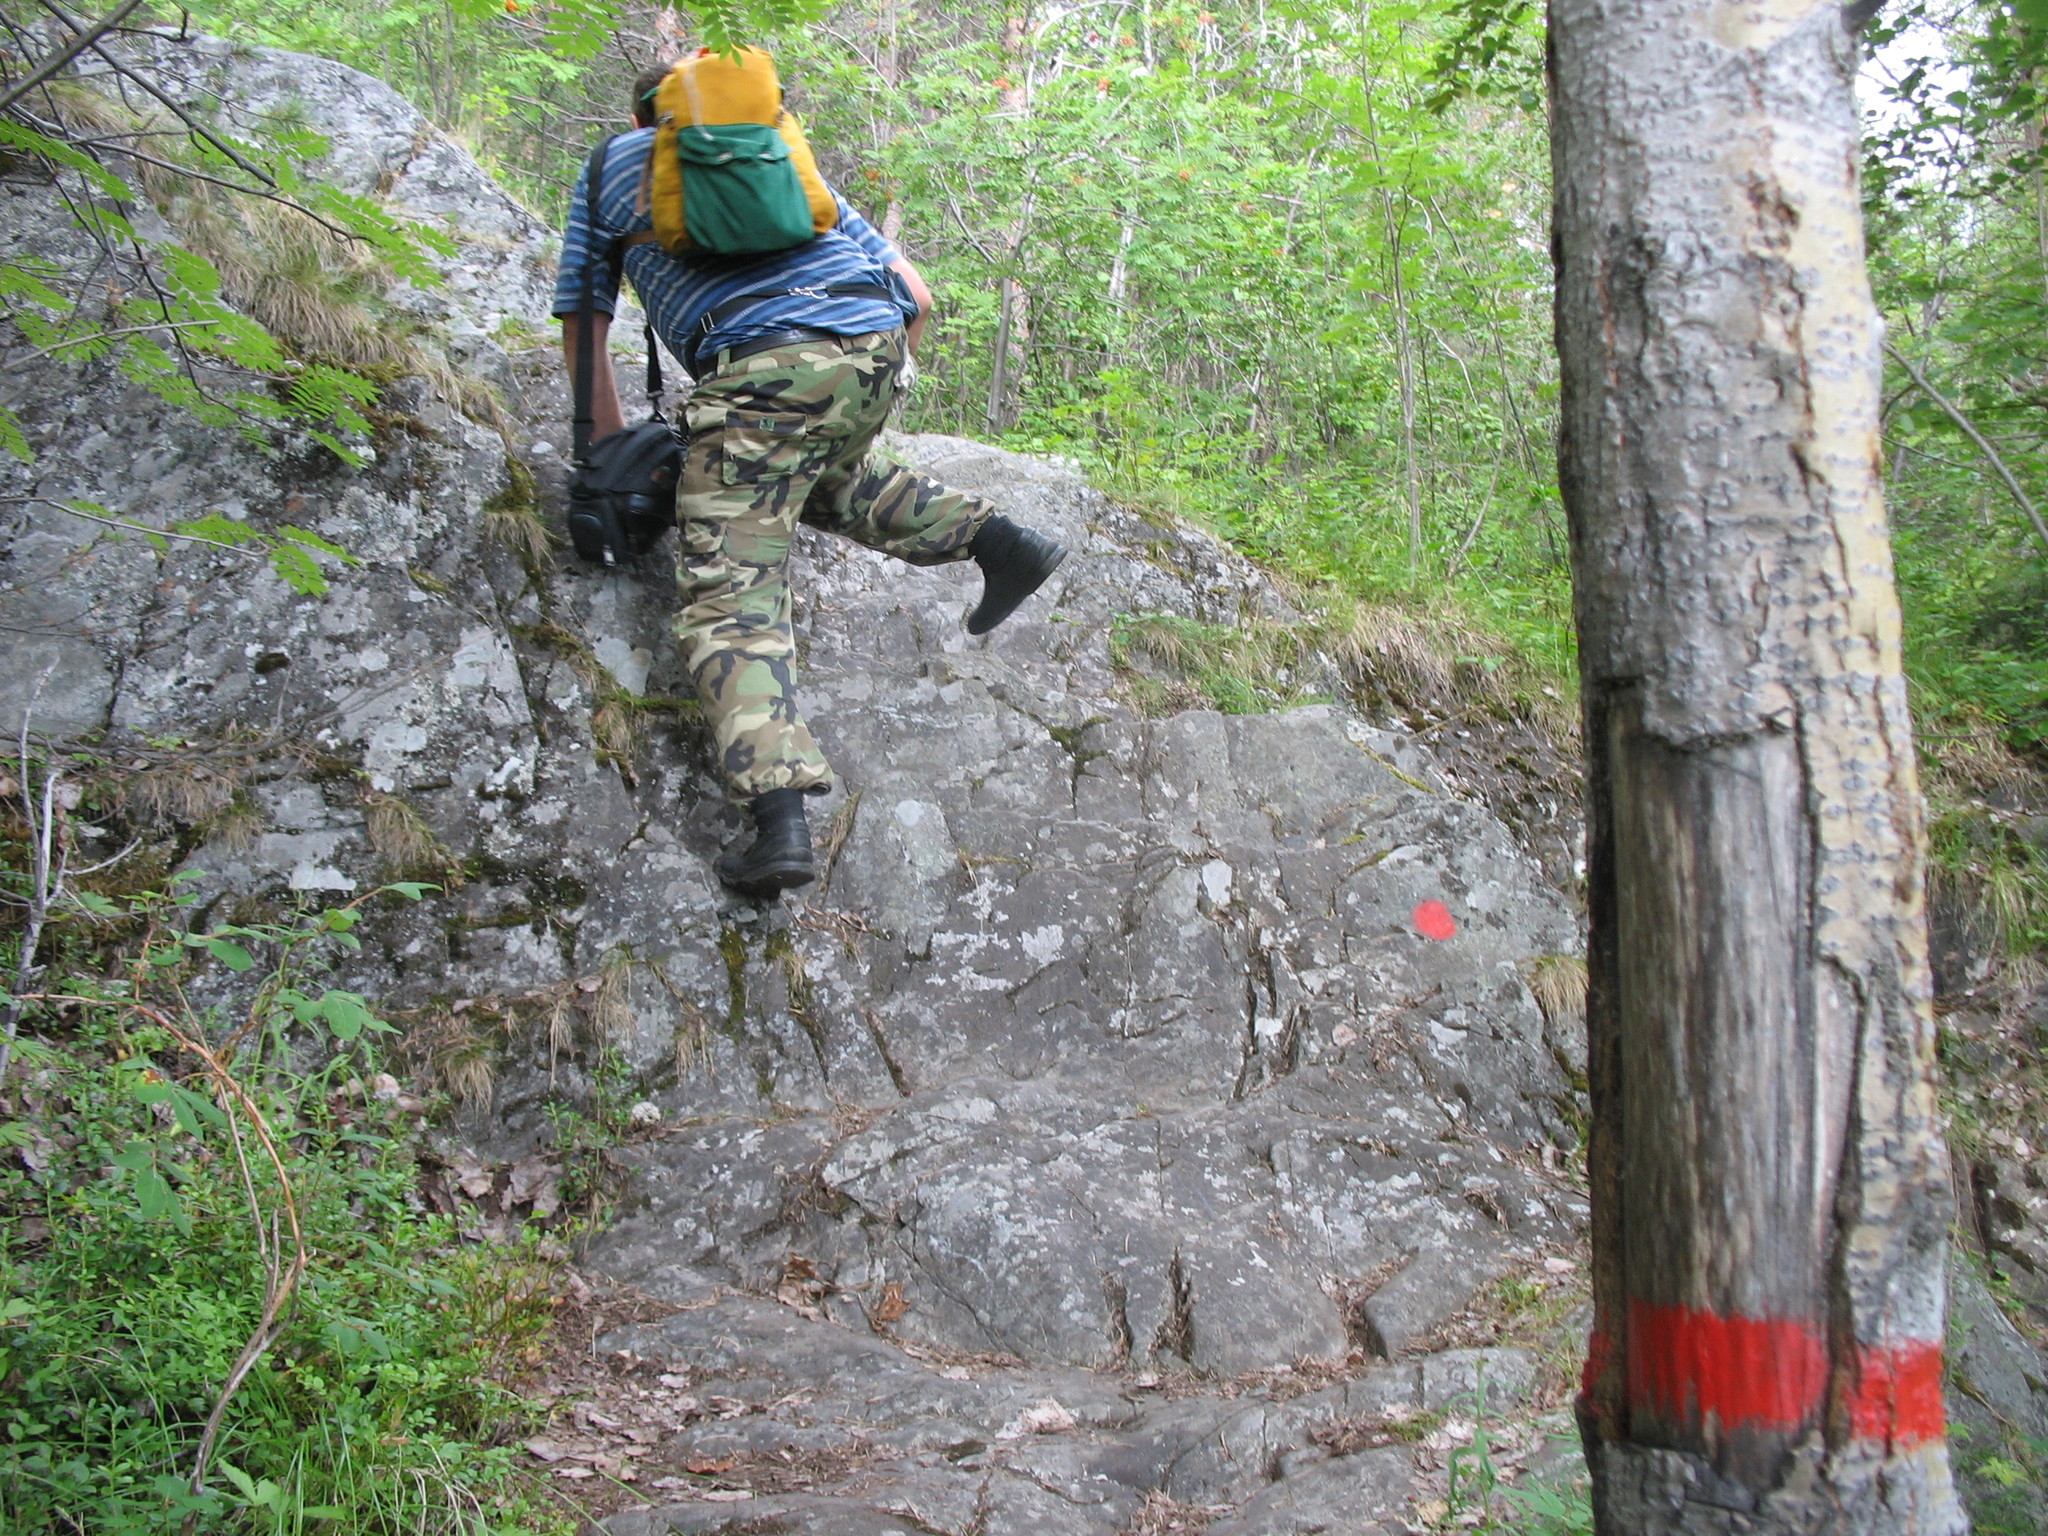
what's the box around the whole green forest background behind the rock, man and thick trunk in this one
[163,0,2048,965]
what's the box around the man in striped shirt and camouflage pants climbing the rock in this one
[555,49,1067,897]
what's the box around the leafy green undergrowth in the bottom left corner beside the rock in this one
[0,874,569,1536]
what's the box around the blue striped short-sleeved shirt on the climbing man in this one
[555,129,918,365]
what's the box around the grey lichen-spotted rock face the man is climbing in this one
[0,30,1585,1536]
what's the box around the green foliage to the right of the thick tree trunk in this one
[1866,0,2048,774]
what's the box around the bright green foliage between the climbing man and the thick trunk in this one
[782,4,1571,674]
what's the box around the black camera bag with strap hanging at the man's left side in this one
[569,139,682,565]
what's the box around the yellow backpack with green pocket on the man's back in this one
[641,47,840,256]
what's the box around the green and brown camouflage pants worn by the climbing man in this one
[674,332,995,801]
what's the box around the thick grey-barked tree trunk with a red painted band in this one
[1550,0,1966,1536]
